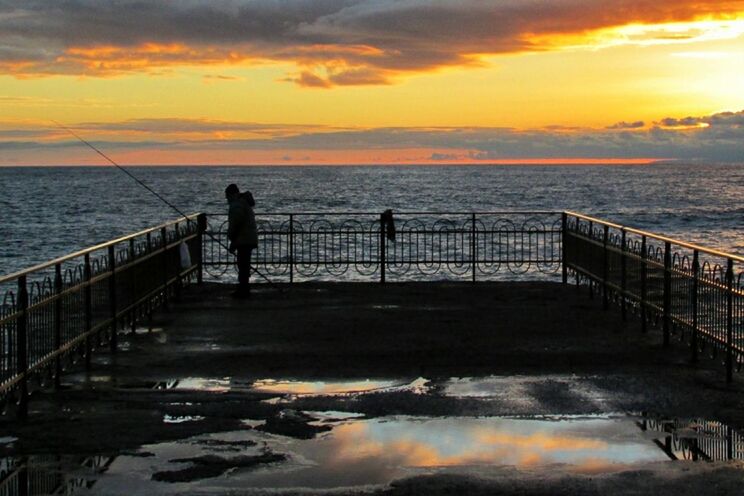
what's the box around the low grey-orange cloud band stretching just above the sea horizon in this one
[0,110,744,163]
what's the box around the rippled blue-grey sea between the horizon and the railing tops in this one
[0,164,744,274]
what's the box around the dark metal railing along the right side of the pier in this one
[563,212,744,382]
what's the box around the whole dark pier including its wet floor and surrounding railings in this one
[0,212,744,494]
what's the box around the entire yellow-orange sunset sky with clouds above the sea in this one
[0,0,744,166]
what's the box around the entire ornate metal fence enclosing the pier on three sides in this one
[0,212,744,417]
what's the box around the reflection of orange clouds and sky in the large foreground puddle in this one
[83,412,667,493]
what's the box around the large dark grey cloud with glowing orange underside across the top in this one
[0,0,744,88]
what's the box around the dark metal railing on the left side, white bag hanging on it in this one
[0,215,205,417]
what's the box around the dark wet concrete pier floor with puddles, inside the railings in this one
[0,283,744,494]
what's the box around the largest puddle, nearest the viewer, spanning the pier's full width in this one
[0,411,744,495]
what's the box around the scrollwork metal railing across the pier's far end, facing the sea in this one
[204,212,561,282]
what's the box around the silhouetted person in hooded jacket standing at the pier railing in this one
[225,184,258,298]
